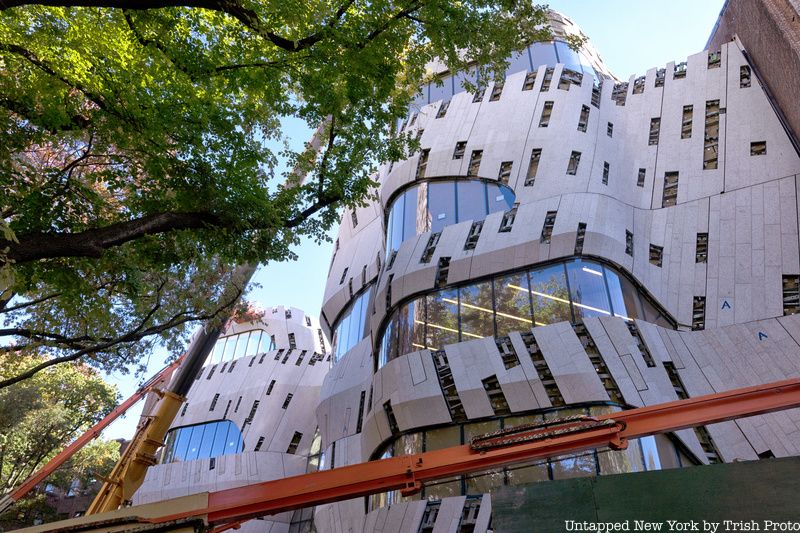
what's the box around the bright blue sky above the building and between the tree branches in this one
[103,0,724,439]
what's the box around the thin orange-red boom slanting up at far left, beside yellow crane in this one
[0,356,184,513]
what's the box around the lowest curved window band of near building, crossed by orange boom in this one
[369,405,661,510]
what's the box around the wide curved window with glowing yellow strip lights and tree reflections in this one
[378,259,673,367]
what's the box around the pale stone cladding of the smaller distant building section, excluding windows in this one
[134,306,331,533]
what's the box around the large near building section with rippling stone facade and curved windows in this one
[315,7,800,533]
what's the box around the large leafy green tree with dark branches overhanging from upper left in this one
[0,0,550,388]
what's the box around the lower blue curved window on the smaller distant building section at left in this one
[161,420,244,463]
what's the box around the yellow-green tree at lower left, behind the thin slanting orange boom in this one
[0,354,117,494]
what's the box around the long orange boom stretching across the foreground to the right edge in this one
[18,378,800,533]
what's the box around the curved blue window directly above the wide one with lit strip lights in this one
[386,179,515,256]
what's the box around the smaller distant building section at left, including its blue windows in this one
[134,307,331,533]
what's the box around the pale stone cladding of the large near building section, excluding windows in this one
[315,35,800,533]
